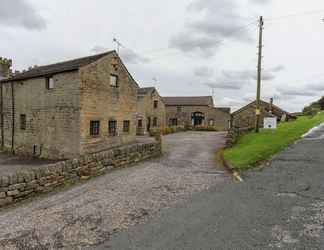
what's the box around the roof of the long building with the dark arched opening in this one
[162,96,213,106]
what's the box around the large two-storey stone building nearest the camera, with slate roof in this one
[0,51,139,159]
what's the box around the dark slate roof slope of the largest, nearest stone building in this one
[1,51,114,82]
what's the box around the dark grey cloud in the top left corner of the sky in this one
[0,0,46,30]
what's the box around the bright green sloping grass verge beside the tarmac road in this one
[224,113,324,170]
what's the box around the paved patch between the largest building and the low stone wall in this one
[0,152,55,175]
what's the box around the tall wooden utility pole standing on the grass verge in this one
[255,16,264,133]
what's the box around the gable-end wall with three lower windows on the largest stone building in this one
[79,53,138,154]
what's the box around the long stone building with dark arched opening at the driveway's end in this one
[163,96,231,130]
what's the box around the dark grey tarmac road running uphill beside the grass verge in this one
[95,128,324,250]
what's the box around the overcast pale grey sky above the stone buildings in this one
[0,0,324,111]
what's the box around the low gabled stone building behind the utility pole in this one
[232,99,295,129]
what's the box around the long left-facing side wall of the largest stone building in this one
[3,71,80,159]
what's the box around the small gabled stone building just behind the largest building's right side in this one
[136,87,166,135]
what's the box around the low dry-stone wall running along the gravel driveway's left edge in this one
[0,142,162,207]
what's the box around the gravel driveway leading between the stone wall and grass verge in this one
[0,132,229,250]
